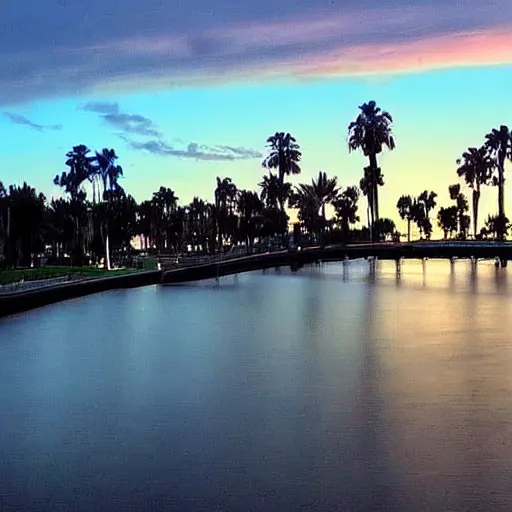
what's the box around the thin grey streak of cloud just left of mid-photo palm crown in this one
[121,136,263,161]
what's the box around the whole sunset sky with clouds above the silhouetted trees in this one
[0,0,512,236]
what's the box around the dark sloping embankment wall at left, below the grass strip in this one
[0,270,162,317]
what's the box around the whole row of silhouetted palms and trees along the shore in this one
[0,101,512,269]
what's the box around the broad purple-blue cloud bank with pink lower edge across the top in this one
[0,0,512,104]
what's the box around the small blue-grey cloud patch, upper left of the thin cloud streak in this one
[80,102,161,137]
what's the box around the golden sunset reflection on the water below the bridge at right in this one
[367,261,512,510]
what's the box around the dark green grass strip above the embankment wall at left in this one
[0,260,156,285]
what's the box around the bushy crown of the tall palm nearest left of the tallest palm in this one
[262,132,302,183]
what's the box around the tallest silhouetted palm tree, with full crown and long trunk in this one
[348,101,395,230]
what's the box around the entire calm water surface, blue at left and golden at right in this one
[0,261,512,512]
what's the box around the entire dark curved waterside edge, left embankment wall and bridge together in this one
[0,242,512,318]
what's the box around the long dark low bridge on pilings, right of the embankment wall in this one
[160,241,512,284]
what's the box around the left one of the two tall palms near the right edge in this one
[457,146,493,238]
